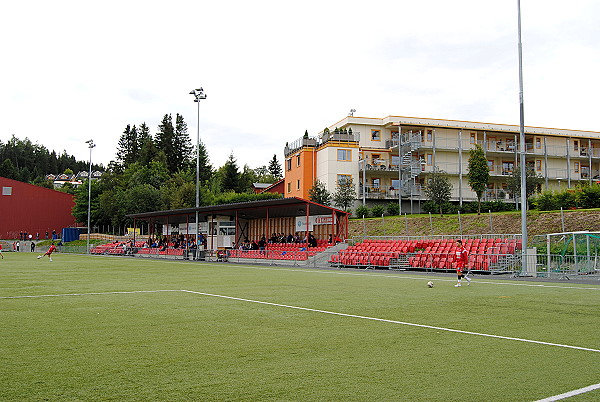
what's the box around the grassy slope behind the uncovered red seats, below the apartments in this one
[349,209,600,238]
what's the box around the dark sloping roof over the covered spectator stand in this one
[127,197,348,223]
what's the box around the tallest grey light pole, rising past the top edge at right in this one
[517,0,527,273]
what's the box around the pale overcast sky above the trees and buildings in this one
[0,0,600,168]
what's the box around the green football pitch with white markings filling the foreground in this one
[0,253,600,401]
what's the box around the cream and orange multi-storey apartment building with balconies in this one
[284,116,600,211]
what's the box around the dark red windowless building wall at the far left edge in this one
[0,177,76,239]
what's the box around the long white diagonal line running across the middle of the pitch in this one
[182,290,600,353]
